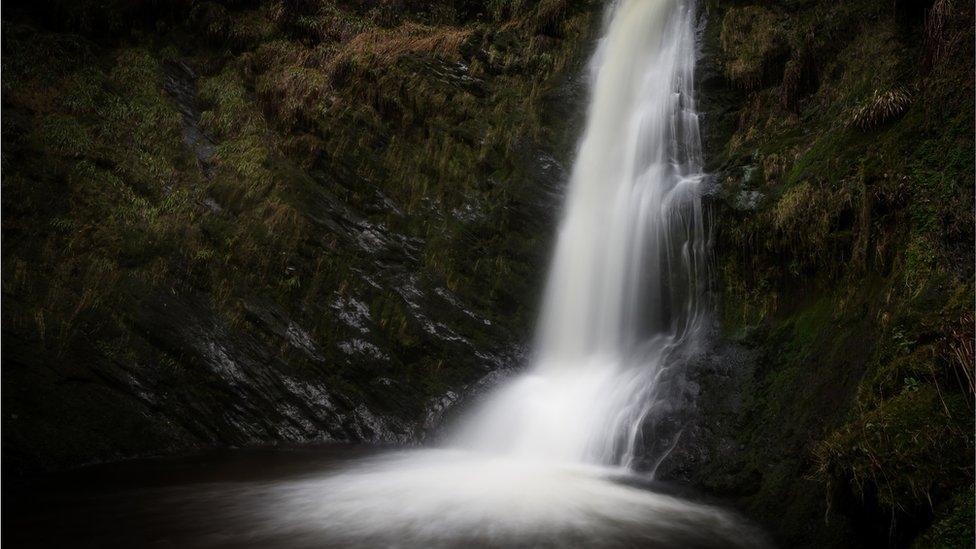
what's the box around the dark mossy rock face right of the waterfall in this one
[657,0,973,547]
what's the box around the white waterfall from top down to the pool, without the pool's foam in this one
[457,0,708,466]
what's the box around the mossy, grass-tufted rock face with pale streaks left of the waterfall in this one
[3,1,599,473]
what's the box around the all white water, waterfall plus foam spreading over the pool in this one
[240,0,764,547]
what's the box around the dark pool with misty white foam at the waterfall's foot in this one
[3,446,766,549]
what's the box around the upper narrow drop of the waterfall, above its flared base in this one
[540,0,704,358]
